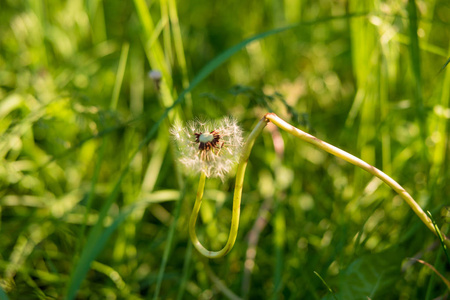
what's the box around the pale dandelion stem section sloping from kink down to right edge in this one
[265,113,450,247]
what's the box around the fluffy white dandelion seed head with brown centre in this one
[170,117,244,180]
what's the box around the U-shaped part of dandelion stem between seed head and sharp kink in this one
[189,117,268,258]
